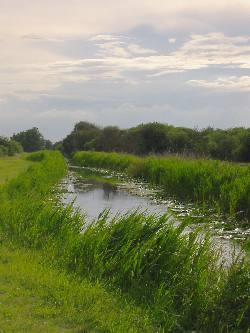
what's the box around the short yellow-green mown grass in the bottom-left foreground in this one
[0,240,152,333]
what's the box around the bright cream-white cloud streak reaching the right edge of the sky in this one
[48,33,250,78]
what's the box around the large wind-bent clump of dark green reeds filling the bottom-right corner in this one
[69,213,250,332]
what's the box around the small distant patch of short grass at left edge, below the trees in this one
[0,155,31,185]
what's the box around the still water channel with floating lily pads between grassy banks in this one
[62,166,250,263]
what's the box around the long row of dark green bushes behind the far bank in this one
[60,122,250,162]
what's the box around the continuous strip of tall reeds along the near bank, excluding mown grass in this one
[0,152,250,333]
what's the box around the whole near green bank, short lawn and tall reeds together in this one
[0,152,250,333]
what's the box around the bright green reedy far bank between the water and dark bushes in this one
[73,152,250,221]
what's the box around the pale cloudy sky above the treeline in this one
[0,0,250,141]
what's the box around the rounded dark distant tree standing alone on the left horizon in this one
[13,127,46,152]
